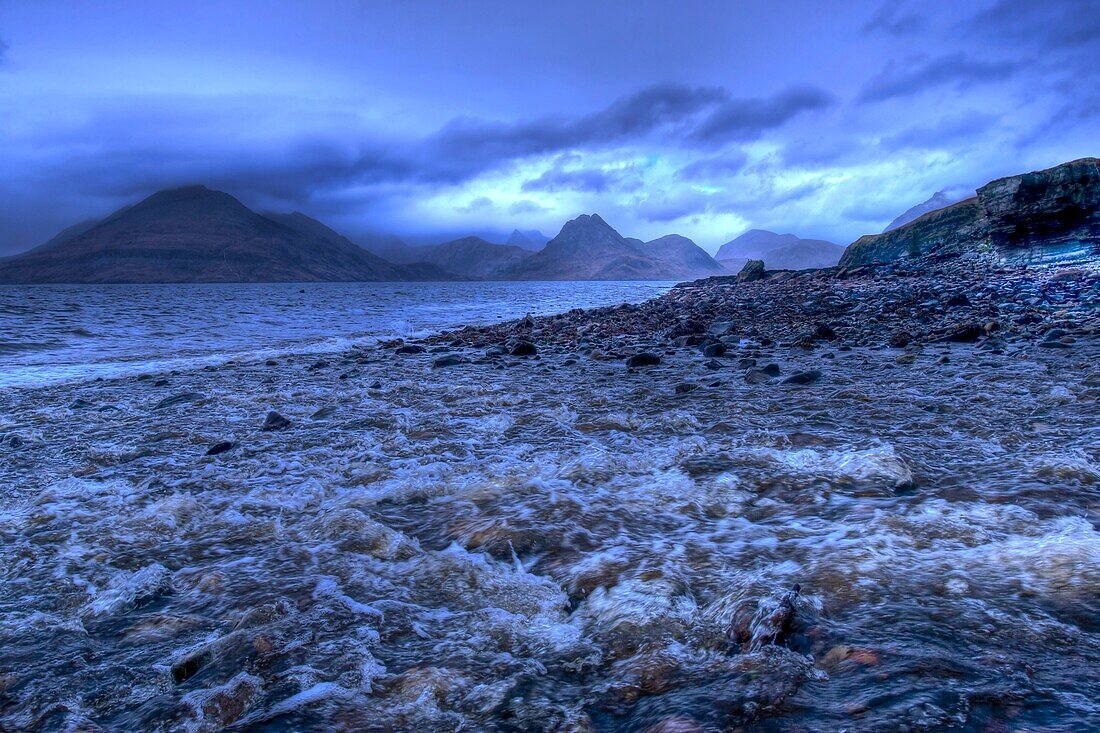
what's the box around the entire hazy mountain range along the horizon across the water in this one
[0,179,924,283]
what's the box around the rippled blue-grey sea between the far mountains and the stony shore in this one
[0,282,672,387]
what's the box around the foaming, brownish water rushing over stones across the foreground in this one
[0,288,1100,733]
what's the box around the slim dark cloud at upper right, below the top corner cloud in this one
[859,52,1019,102]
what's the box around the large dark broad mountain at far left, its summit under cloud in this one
[0,186,451,283]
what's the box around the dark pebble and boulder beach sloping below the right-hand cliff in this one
[413,254,1100,365]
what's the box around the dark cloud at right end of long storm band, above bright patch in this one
[689,87,835,143]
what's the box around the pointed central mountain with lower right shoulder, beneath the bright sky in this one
[506,214,716,280]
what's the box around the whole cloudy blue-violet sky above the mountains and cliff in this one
[0,0,1100,255]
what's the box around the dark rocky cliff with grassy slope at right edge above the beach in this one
[840,157,1100,266]
